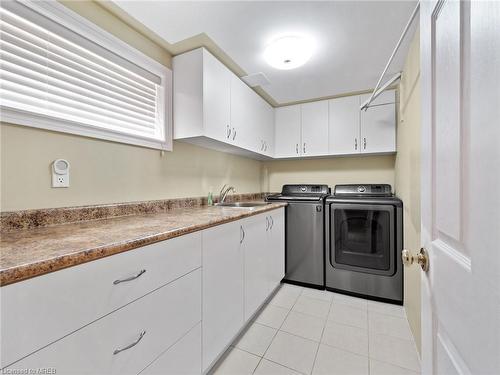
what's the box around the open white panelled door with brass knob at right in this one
[420,0,500,375]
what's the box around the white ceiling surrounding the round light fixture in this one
[114,0,417,104]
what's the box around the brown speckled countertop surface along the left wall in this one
[0,203,286,286]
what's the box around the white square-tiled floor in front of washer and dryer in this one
[209,284,420,375]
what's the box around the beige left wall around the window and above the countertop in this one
[0,1,261,211]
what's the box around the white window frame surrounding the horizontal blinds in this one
[0,0,172,151]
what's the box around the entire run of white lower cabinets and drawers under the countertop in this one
[0,208,285,375]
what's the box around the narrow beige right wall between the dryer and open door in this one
[396,30,421,351]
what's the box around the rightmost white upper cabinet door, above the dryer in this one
[361,103,396,153]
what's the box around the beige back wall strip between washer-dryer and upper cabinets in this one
[262,155,394,192]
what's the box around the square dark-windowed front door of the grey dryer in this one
[329,203,396,276]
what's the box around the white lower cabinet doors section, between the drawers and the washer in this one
[202,208,285,372]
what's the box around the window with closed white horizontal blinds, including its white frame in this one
[0,0,171,149]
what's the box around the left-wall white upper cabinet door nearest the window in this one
[203,50,232,142]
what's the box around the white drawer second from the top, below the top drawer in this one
[5,269,201,375]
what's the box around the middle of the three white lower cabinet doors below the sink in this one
[241,215,269,320]
